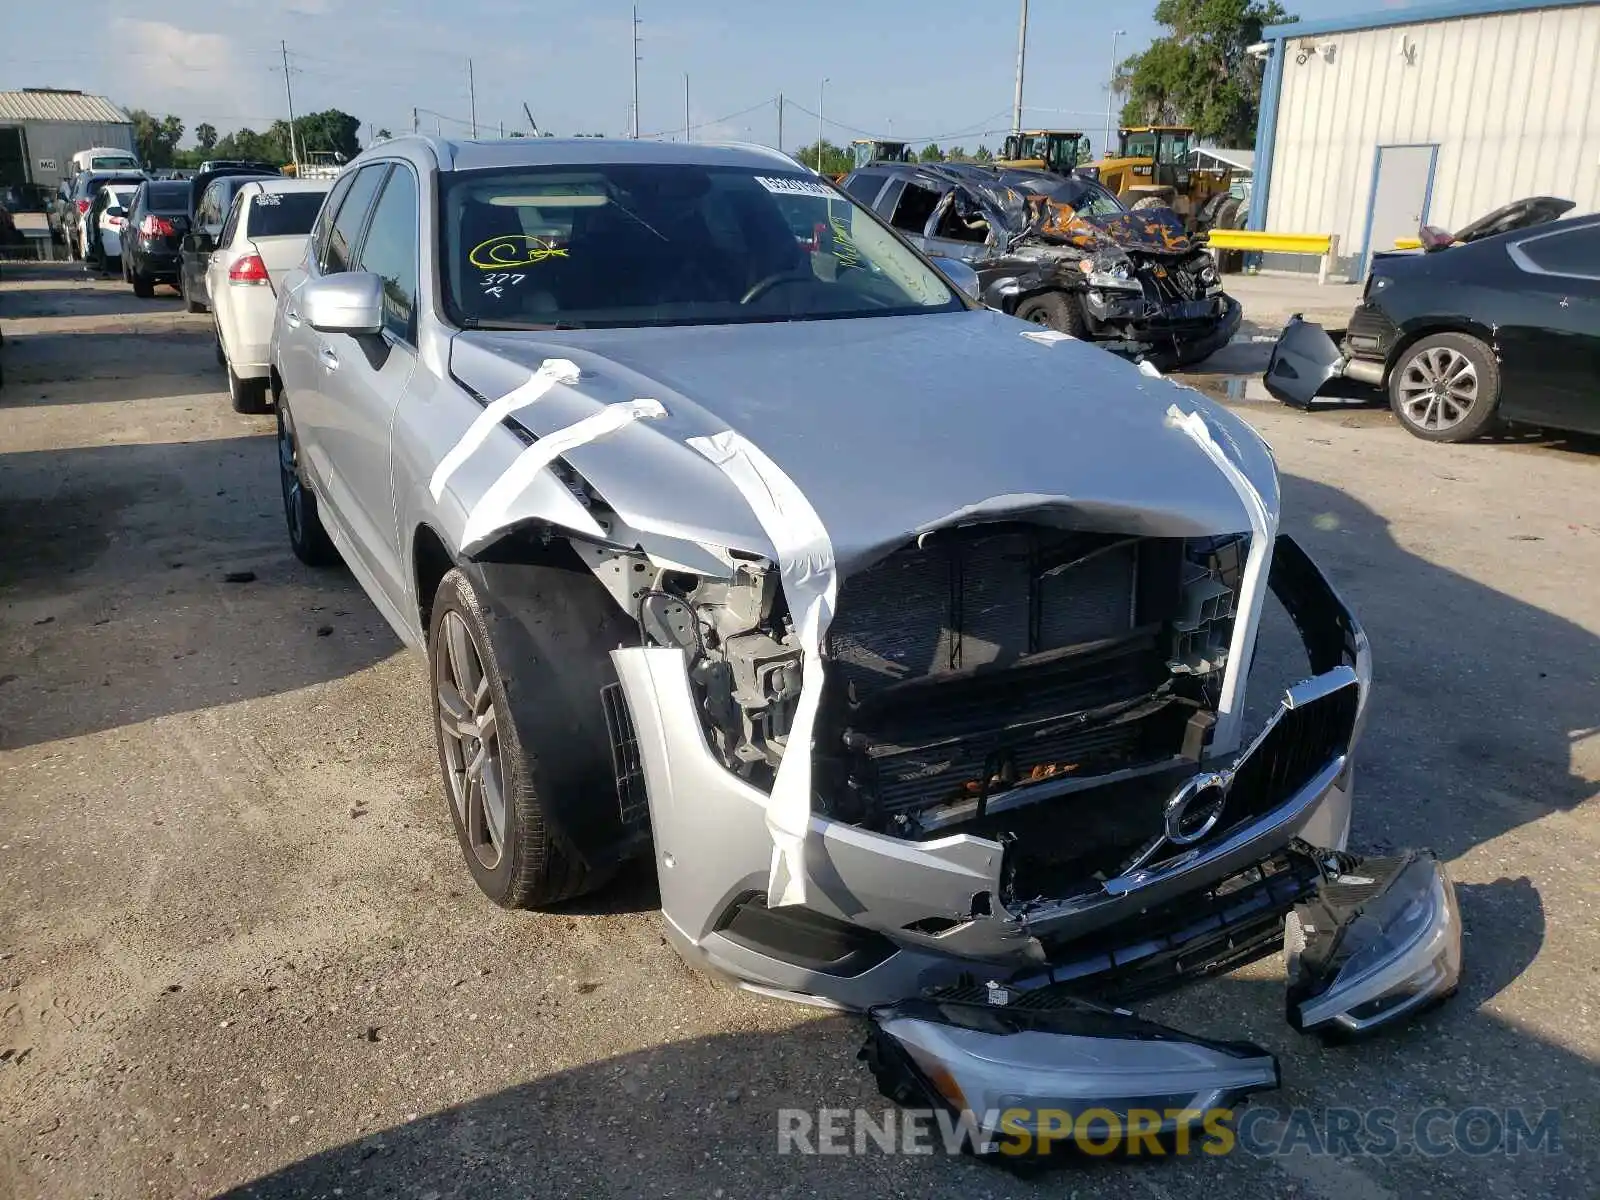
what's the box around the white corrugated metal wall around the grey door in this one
[1267,5,1600,256]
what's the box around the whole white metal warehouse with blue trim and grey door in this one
[1250,0,1600,278]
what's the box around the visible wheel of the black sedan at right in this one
[1389,333,1501,442]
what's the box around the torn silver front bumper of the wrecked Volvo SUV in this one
[613,538,1371,1010]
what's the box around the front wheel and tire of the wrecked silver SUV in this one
[427,566,621,909]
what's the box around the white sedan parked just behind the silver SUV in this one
[205,179,333,413]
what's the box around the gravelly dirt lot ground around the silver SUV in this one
[0,266,1600,1200]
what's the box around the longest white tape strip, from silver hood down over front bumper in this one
[690,430,838,907]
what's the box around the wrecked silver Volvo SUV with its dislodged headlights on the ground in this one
[272,138,1461,1158]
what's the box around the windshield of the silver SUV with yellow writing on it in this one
[440,163,965,328]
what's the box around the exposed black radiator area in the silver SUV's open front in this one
[824,525,1192,819]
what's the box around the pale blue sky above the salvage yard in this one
[0,0,1427,150]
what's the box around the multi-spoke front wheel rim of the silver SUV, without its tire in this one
[434,613,507,870]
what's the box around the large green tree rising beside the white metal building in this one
[1112,0,1294,146]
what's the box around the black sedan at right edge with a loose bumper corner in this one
[1266,197,1600,442]
